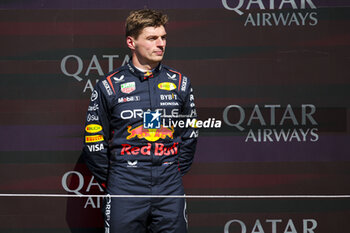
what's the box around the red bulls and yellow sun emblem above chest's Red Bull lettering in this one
[126,125,174,142]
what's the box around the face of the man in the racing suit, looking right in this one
[132,26,166,66]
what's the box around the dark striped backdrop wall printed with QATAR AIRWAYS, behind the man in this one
[0,0,350,233]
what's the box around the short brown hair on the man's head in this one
[125,9,169,39]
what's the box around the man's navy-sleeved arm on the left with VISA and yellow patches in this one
[83,81,110,186]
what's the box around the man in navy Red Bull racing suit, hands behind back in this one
[83,9,198,233]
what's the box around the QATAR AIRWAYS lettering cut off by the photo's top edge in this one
[221,0,318,27]
